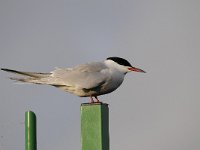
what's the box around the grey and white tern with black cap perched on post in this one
[1,57,145,103]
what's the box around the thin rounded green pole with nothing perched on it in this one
[25,111,37,150]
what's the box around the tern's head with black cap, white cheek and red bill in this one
[105,57,146,74]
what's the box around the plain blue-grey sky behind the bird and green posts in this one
[0,0,200,150]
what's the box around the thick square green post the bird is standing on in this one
[81,103,109,150]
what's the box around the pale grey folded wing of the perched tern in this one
[52,63,107,89]
